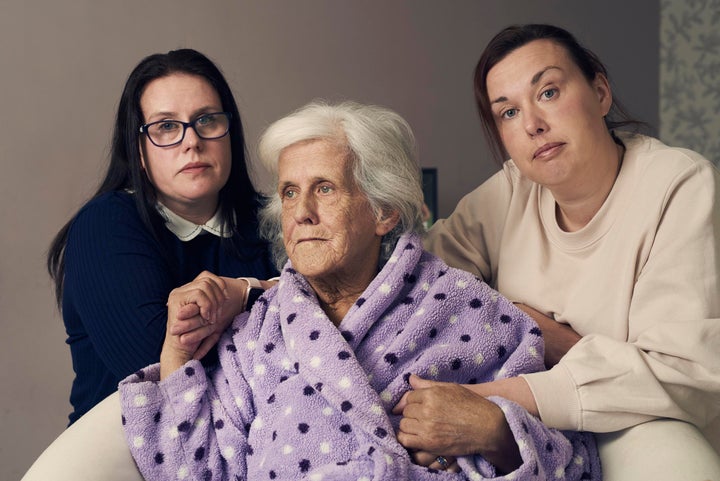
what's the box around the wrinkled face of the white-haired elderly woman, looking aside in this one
[278,140,395,283]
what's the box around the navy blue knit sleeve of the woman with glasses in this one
[63,194,177,379]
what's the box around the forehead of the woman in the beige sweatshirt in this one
[487,39,580,94]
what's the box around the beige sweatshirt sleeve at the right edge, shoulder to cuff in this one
[524,158,720,432]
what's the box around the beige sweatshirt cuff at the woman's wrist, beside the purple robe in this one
[521,363,583,431]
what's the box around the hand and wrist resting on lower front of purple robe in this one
[393,375,522,472]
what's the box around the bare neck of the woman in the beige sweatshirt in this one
[553,141,625,232]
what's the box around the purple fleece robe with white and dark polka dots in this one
[120,231,600,481]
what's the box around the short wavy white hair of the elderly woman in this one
[258,101,425,269]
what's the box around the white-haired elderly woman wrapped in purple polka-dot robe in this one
[22,99,601,480]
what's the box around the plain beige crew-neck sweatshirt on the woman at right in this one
[426,131,720,438]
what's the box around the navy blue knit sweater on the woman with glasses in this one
[62,192,276,424]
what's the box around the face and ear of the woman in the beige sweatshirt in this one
[487,40,612,189]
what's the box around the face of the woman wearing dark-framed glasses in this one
[140,74,231,223]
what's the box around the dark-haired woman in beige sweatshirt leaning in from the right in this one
[396,25,720,480]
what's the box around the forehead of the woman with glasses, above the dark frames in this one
[140,73,221,114]
